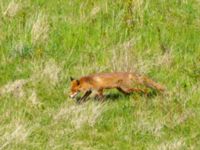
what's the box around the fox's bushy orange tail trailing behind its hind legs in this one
[143,77,165,92]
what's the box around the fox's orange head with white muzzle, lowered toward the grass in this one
[70,77,80,98]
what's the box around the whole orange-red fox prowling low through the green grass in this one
[70,72,165,101]
